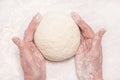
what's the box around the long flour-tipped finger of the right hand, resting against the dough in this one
[71,12,94,38]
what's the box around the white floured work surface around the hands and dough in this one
[0,0,120,80]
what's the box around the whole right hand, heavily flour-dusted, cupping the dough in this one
[71,12,105,80]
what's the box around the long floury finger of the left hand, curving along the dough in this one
[24,13,41,41]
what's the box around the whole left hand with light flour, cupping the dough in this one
[12,13,46,80]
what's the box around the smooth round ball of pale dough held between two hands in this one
[34,13,80,61]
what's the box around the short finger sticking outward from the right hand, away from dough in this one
[93,29,106,48]
